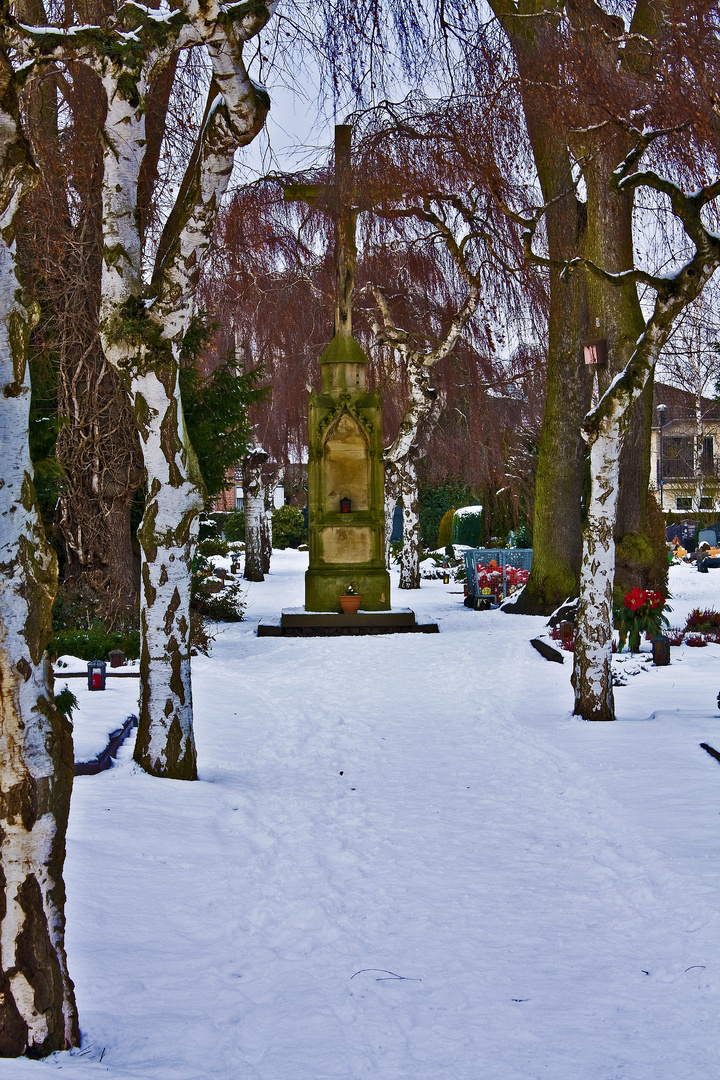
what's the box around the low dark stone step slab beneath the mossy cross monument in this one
[258,608,438,637]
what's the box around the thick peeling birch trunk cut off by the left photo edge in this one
[0,48,79,1057]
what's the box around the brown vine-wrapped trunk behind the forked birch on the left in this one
[19,29,142,630]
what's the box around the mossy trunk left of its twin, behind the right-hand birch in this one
[490,10,592,615]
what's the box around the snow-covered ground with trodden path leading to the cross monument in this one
[8,551,720,1080]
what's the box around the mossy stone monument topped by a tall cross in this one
[285,124,390,611]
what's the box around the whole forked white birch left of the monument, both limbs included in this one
[21,0,276,780]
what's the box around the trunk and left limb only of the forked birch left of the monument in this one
[95,56,204,780]
